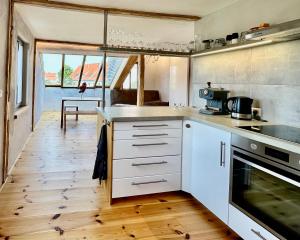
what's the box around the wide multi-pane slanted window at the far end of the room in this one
[42,53,127,88]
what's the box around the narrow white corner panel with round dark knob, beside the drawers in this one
[181,120,194,193]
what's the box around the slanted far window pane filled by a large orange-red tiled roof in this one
[81,56,102,87]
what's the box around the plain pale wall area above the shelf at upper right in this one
[195,0,300,40]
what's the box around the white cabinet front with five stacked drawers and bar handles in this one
[112,120,182,198]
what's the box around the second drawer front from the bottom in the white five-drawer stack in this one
[113,155,181,179]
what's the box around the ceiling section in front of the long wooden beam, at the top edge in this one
[47,0,238,17]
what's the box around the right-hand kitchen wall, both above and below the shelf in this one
[190,0,300,126]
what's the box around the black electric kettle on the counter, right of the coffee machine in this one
[227,97,253,120]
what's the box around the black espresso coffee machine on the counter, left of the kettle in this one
[199,82,229,115]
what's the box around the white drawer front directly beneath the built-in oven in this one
[229,205,279,240]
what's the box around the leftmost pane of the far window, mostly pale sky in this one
[43,53,62,86]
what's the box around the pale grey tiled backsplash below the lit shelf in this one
[190,40,300,126]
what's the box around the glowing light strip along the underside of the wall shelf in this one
[191,40,273,57]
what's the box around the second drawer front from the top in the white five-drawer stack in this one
[114,128,182,140]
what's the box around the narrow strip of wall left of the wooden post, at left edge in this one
[0,0,9,183]
